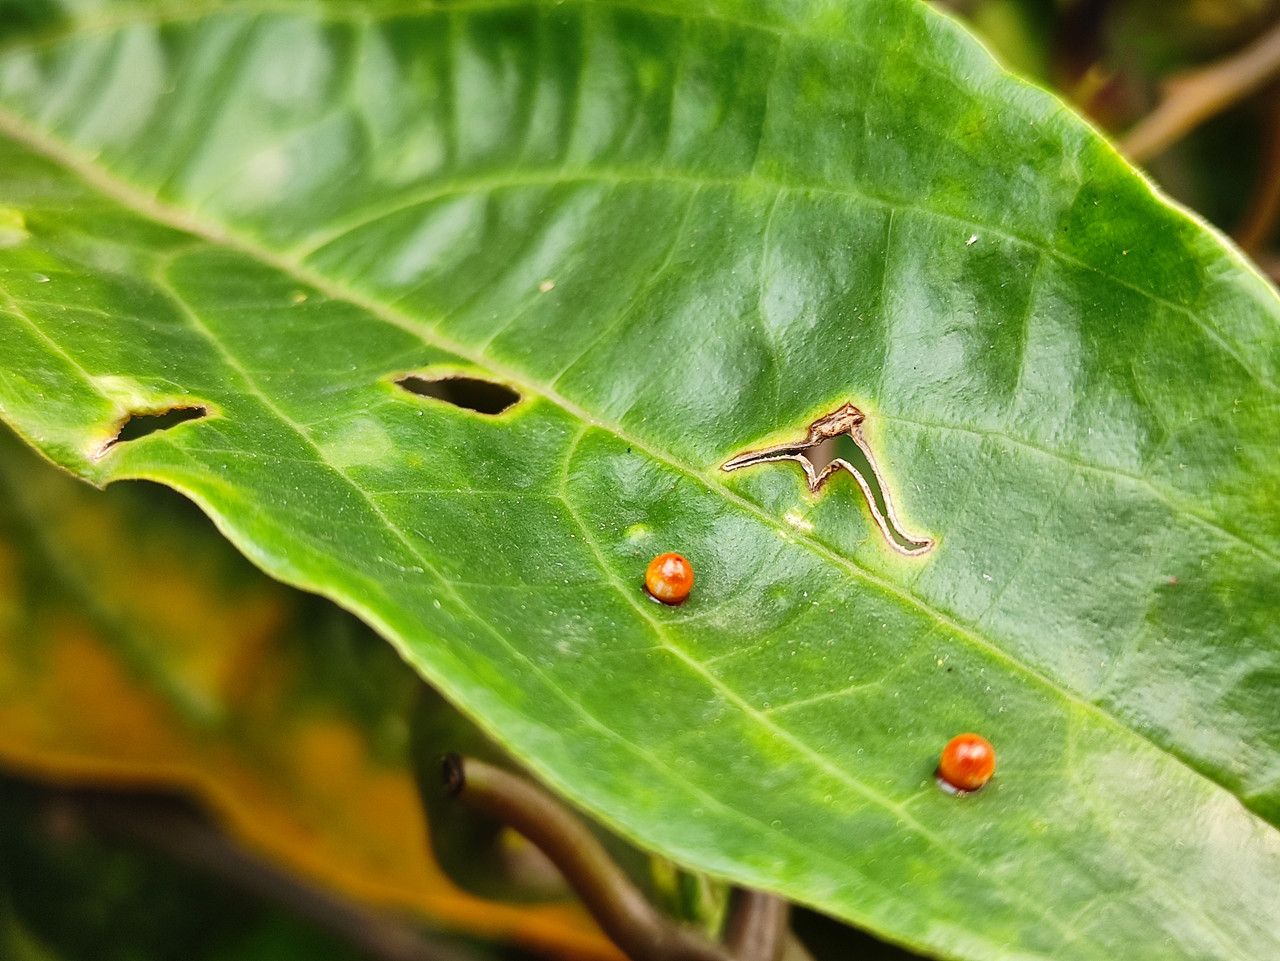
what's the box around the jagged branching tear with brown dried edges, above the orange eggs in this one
[721,403,933,557]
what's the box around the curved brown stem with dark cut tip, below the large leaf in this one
[444,755,735,961]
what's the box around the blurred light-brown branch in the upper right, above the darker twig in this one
[1120,23,1280,161]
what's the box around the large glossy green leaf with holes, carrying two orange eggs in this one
[0,0,1280,961]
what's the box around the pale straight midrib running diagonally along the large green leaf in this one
[0,107,1257,834]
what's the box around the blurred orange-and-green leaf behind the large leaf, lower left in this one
[0,431,617,961]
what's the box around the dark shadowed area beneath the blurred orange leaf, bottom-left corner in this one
[0,772,514,961]
